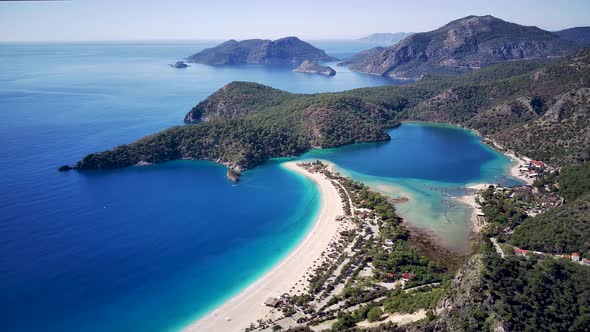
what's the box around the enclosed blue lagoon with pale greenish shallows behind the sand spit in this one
[302,123,519,251]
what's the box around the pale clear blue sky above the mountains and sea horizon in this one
[0,0,590,42]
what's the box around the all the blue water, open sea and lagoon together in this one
[0,41,520,331]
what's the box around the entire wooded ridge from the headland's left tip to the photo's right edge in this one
[70,49,590,176]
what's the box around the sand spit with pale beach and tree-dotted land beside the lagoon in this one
[185,160,450,332]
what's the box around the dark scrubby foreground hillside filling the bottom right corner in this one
[414,248,590,331]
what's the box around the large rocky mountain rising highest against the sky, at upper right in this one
[351,15,579,79]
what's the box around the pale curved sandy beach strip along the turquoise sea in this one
[184,162,346,332]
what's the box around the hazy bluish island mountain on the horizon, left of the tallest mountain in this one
[187,37,337,67]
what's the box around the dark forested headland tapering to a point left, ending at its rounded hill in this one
[75,82,399,171]
